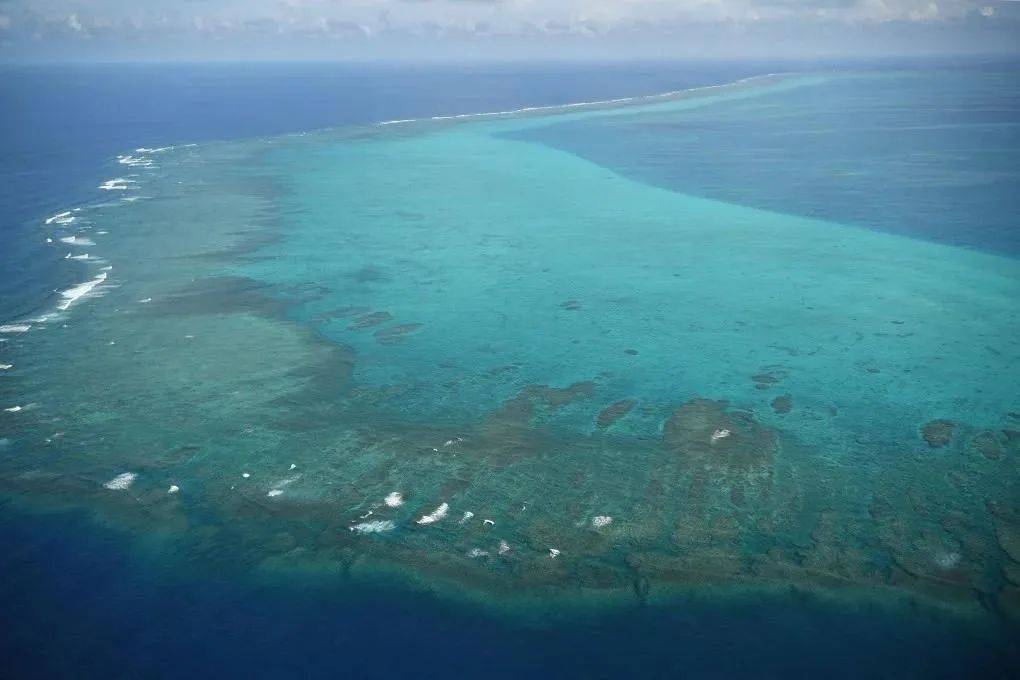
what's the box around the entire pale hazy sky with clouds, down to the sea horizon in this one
[0,0,1020,61]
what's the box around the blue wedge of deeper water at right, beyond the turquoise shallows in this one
[525,63,1020,257]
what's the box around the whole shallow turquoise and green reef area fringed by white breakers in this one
[0,66,1020,672]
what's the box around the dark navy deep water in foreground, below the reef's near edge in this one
[0,515,1017,679]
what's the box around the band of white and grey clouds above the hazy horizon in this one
[0,0,1020,56]
